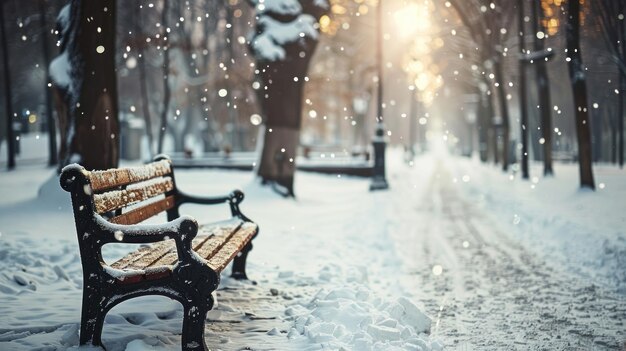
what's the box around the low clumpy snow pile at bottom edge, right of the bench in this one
[285,285,442,351]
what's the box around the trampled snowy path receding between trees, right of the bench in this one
[395,161,626,350]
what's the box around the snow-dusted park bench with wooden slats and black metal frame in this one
[60,156,258,351]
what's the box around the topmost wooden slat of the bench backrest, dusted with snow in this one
[88,160,172,192]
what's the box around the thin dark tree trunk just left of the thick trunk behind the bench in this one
[39,0,59,166]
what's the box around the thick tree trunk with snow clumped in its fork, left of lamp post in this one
[250,0,329,196]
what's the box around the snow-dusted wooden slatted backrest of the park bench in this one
[61,158,176,224]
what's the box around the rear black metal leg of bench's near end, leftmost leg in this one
[80,293,106,346]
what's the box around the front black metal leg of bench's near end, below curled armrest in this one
[182,297,213,351]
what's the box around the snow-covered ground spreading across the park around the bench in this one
[0,136,626,350]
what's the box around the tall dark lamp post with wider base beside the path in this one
[370,1,389,191]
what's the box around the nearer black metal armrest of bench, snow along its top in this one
[96,215,198,262]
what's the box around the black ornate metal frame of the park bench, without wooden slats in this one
[60,155,258,351]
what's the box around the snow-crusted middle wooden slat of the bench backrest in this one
[93,177,174,214]
